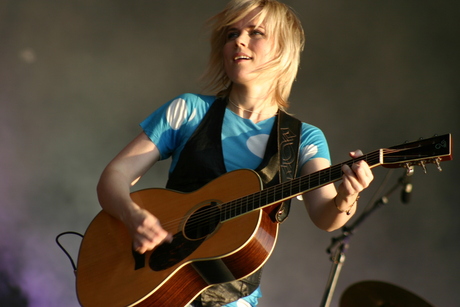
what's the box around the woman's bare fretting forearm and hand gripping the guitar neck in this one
[301,150,374,231]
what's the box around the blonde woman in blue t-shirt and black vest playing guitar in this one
[98,0,373,306]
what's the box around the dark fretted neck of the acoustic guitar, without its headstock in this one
[220,149,383,221]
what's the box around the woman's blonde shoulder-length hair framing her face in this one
[203,0,305,110]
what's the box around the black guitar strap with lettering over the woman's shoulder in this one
[275,111,302,223]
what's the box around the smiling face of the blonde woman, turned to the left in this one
[223,8,274,85]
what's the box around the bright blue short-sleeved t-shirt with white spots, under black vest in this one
[140,94,330,176]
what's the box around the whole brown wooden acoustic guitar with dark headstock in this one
[76,134,452,307]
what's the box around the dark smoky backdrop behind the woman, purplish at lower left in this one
[0,0,460,307]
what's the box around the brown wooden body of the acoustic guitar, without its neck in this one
[76,170,278,307]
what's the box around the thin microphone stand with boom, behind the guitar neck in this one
[320,167,413,307]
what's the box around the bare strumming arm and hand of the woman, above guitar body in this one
[97,132,172,254]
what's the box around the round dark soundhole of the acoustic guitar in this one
[184,202,220,240]
